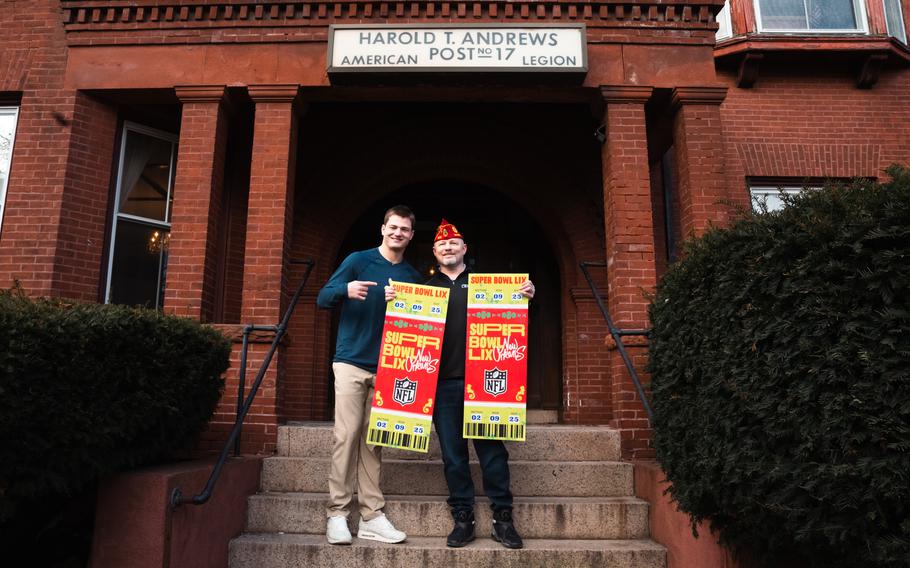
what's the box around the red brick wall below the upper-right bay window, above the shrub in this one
[719,62,910,197]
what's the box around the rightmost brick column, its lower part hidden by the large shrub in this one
[672,87,730,239]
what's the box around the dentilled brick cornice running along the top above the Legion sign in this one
[60,0,723,39]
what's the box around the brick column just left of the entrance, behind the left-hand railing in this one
[212,85,298,453]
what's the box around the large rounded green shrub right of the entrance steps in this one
[650,168,910,568]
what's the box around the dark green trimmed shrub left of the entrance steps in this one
[0,291,230,521]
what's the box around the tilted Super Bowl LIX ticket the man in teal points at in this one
[367,281,449,452]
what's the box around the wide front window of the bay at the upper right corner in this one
[755,0,866,33]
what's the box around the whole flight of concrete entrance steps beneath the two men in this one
[230,422,666,568]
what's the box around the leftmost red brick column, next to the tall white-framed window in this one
[164,85,228,322]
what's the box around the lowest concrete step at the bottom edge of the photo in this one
[230,533,666,568]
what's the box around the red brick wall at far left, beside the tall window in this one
[0,0,115,300]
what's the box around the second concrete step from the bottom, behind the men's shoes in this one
[247,493,648,539]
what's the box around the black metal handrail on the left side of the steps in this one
[171,259,316,507]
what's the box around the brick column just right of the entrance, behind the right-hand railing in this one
[601,86,656,458]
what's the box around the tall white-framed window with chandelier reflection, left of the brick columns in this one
[105,122,177,308]
